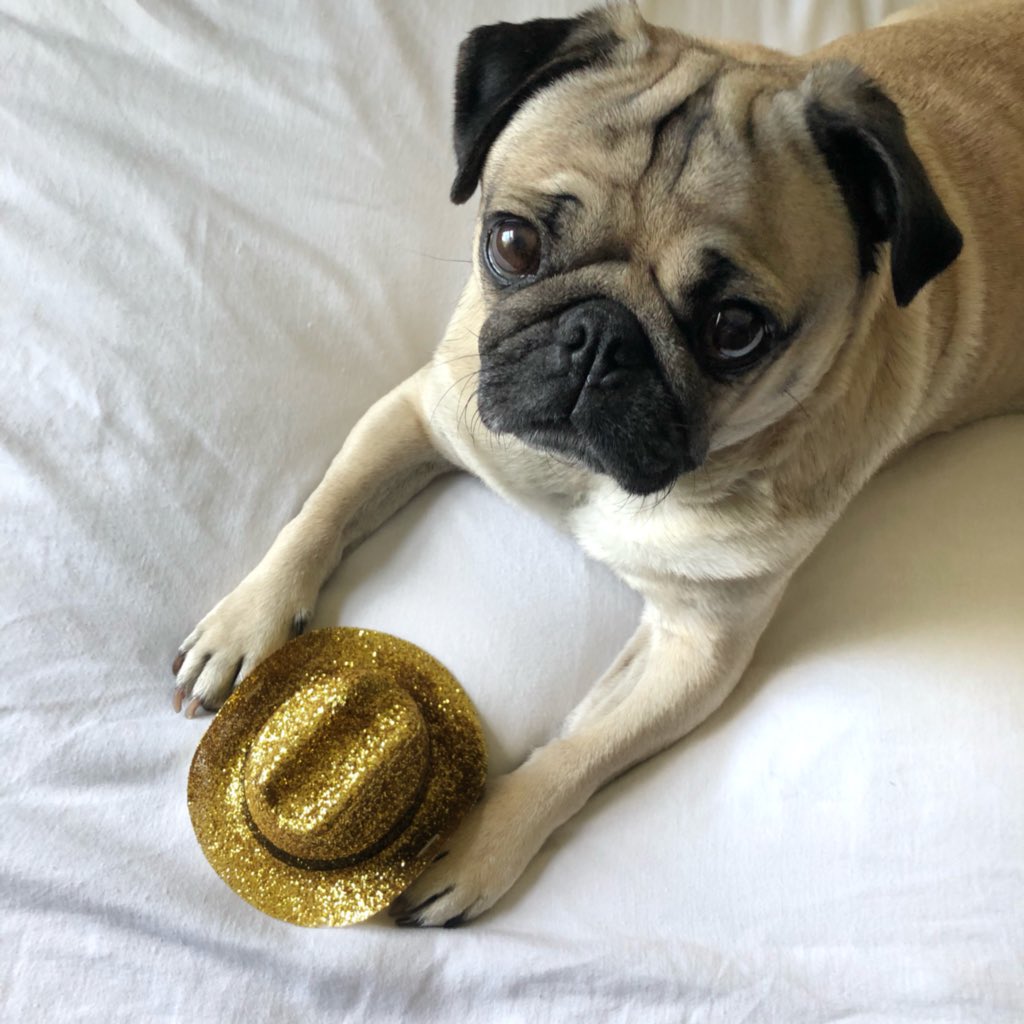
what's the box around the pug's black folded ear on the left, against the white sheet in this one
[452,10,617,203]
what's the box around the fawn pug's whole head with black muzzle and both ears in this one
[452,5,961,495]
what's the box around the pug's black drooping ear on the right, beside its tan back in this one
[802,61,963,306]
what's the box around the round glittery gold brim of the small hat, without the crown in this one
[188,628,486,927]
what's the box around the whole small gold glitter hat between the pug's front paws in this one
[188,629,486,926]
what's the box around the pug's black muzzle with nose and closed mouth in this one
[477,298,705,495]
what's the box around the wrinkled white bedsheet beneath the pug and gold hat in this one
[0,0,1024,1024]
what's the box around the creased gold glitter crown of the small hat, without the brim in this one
[244,673,430,863]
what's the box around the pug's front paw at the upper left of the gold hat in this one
[171,570,313,718]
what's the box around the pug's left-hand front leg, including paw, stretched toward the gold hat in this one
[174,367,453,717]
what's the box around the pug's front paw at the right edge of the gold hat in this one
[388,775,547,928]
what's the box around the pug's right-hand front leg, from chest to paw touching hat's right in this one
[391,578,783,925]
